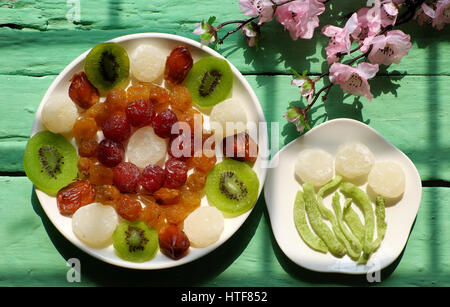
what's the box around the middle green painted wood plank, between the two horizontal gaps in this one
[0,75,450,180]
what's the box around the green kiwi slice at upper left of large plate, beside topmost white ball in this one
[84,43,130,91]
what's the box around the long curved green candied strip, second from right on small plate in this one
[341,182,375,264]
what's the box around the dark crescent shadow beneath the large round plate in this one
[31,189,264,287]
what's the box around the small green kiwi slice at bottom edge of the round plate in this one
[112,220,159,262]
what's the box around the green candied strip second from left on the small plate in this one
[303,182,346,258]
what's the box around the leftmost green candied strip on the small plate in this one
[294,191,328,254]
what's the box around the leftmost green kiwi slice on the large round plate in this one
[23,130,78,196]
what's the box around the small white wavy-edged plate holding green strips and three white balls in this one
[264,119,422,274]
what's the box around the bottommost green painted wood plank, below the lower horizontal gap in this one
[0,177,450,286]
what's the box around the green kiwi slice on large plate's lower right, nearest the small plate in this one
[205,160,259,217]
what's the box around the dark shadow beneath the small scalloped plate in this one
[264,210,416,287]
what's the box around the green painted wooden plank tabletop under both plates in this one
[0,0,450,286]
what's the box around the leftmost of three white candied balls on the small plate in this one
[295,148,334,187]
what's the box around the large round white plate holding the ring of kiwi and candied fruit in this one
[32,33,268,270]
